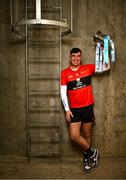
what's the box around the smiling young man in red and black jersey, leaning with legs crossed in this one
[61,48,109,170]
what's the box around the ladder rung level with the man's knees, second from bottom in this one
[31,138,60,144]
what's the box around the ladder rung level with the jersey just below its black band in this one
[29,90,59,96]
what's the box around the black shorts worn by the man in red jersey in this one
[71,105,94,123]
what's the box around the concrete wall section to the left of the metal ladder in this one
[0,1,26,155]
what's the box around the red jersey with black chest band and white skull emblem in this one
[61,64,95,108]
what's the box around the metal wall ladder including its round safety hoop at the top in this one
[10,0,72,162]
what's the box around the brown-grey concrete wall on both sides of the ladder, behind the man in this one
[0,0,126,157]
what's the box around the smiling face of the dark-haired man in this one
[70,52,82,67]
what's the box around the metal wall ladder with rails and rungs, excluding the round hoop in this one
[26,1,62,160]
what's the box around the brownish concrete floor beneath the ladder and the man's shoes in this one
[0,158,126,179]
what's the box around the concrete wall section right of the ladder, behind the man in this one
[62,0,126,157]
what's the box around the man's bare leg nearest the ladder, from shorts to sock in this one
[69,122,90,151]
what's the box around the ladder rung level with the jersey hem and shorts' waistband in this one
[29,107,60,112]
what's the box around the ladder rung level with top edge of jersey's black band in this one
[29,74,59,80]
